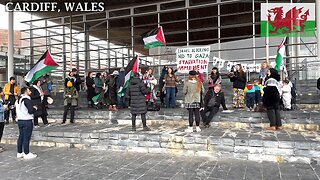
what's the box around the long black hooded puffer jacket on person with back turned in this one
[128,77,148,114]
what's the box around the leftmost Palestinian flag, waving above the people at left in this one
[24,50,59,83]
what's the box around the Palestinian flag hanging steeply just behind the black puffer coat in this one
[118,56,139,97]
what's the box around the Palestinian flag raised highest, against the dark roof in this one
[142,26,166,49]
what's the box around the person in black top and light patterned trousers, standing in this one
[228,64,247,108]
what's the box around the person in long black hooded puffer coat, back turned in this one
[128,73,150,131]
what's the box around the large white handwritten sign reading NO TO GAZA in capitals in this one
[176,46,210,73]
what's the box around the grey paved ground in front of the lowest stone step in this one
[0,146,320,180]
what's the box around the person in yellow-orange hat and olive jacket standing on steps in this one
[62,81,79,124]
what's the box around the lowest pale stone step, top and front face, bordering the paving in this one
[3,123,320,163]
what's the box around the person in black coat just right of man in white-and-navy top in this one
[30,80,49,127]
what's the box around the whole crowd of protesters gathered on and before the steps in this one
[0,62,302,158]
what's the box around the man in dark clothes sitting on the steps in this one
[200,84,228,128]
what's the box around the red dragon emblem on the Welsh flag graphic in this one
[268,6,309,34]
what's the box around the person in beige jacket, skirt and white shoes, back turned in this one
[183,70,204,132]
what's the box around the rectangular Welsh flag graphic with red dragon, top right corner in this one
[260,3,316,37]
